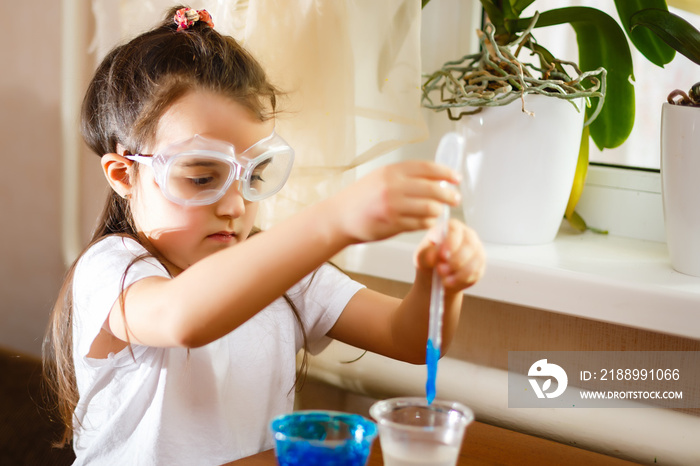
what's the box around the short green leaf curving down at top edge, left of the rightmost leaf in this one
[615,0,676,68]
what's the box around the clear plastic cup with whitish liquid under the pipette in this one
[369,398,474,466]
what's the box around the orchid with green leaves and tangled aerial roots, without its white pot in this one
[422,0,676,230]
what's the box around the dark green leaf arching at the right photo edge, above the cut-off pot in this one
[630,8,700,65]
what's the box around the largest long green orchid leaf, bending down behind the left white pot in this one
[517,7,635,150]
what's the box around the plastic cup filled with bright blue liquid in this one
[271,411,377,466]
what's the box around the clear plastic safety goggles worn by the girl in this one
[125,131,294,205]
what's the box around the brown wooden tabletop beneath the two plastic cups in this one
[228,422,637,466]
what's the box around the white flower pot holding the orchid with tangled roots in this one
[457,95,584,244]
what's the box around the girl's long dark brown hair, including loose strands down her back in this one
[43,6,307,446]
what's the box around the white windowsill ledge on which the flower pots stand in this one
[338,225,700,339]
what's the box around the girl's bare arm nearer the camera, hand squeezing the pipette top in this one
[108,161,459,347]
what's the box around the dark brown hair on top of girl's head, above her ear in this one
[81,7,277,156]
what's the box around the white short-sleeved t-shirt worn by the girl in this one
[73,236,362,466]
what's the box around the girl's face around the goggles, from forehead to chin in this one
[131,91,274,275]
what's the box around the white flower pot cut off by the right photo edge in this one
[661,103,700,277]
